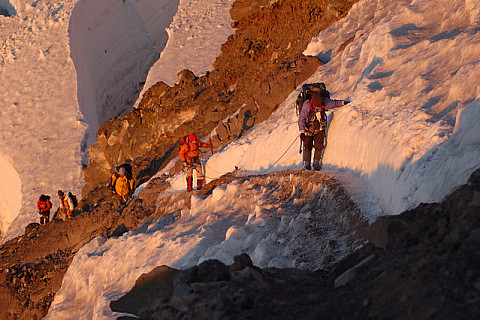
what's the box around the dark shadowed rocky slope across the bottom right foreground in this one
[111,170,480,320]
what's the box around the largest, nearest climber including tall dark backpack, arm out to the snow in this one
[296,83,350,170]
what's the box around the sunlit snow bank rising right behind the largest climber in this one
[202,0,480,214]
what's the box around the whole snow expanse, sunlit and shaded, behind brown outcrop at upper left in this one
[0,0,232,241]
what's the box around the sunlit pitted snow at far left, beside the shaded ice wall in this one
[0,0,81,241]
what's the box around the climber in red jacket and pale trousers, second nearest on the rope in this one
[179,133,212,191]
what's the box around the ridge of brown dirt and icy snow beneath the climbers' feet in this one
[0,171,366,319]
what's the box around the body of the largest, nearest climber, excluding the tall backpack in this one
[298,92,350,170]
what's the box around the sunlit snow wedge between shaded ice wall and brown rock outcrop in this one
[135,0,234,106]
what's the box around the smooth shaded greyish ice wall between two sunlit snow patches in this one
[69,0,178,149]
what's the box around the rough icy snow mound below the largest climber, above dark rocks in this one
[46,174,364,319]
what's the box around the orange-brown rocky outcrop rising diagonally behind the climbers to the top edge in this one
[83,0,355,197]
